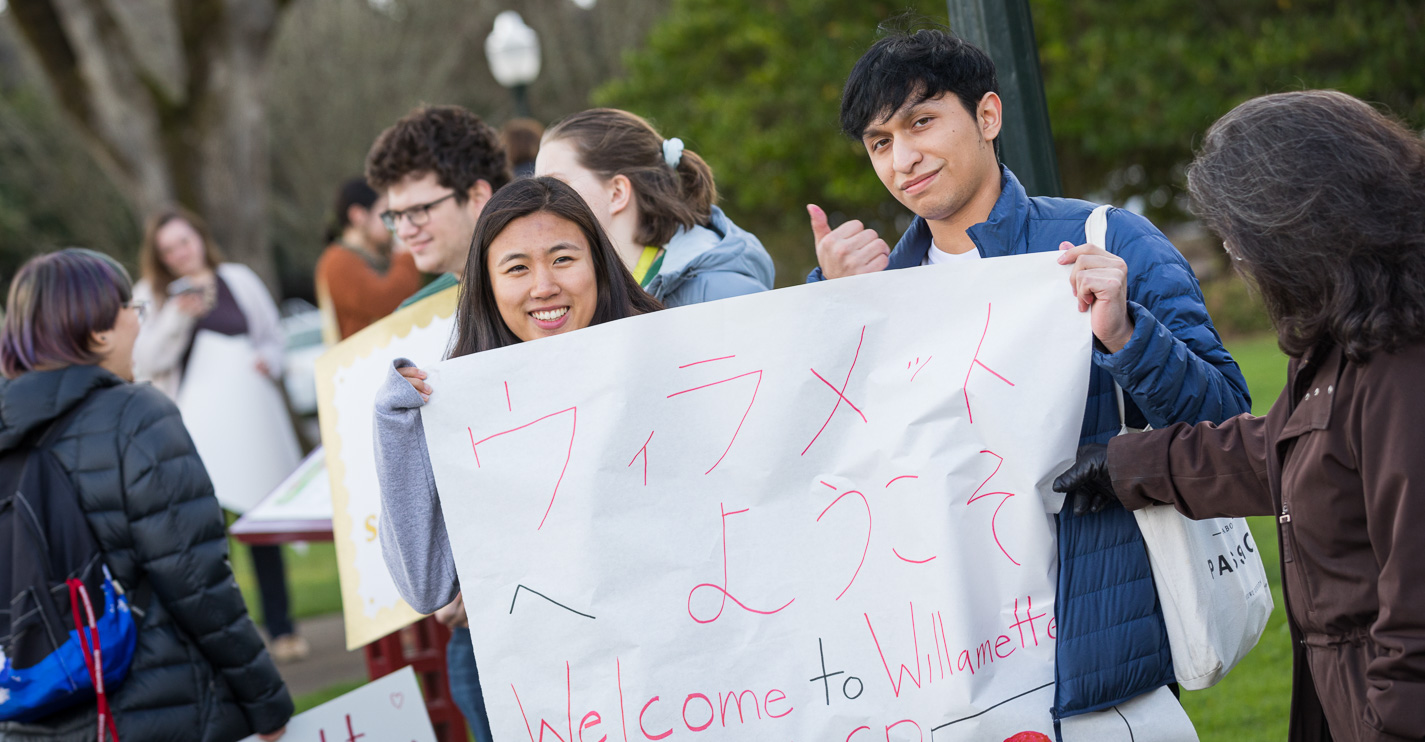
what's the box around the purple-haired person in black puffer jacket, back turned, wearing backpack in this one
[0,249,292,742]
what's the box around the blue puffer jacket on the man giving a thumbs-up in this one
[807,168,1251,719]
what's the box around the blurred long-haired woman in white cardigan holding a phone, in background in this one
[134,207,309,661]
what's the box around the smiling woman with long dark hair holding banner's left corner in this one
[364,178,663,742]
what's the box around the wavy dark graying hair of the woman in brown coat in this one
[1187,90,1425,362]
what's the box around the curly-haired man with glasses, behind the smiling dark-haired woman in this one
[366,105,510,306]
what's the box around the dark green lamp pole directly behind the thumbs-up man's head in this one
[949,0,1063,197]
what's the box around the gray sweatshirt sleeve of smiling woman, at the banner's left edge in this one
[373,357,460,614]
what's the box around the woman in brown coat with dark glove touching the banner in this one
[1056,91,1425,742]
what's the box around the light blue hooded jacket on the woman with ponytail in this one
[647,207,777,308]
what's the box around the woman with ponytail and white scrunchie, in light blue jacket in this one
[534,108,774,308]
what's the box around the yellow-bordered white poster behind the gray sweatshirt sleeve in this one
[316,288,459,649]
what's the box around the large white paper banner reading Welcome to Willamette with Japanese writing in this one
[423,254,1180,742]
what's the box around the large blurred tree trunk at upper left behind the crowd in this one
[10,0,286,288]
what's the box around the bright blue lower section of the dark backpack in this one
[0,568,138,722]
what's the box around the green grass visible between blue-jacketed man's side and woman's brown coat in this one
[1183,336,1291,742]
